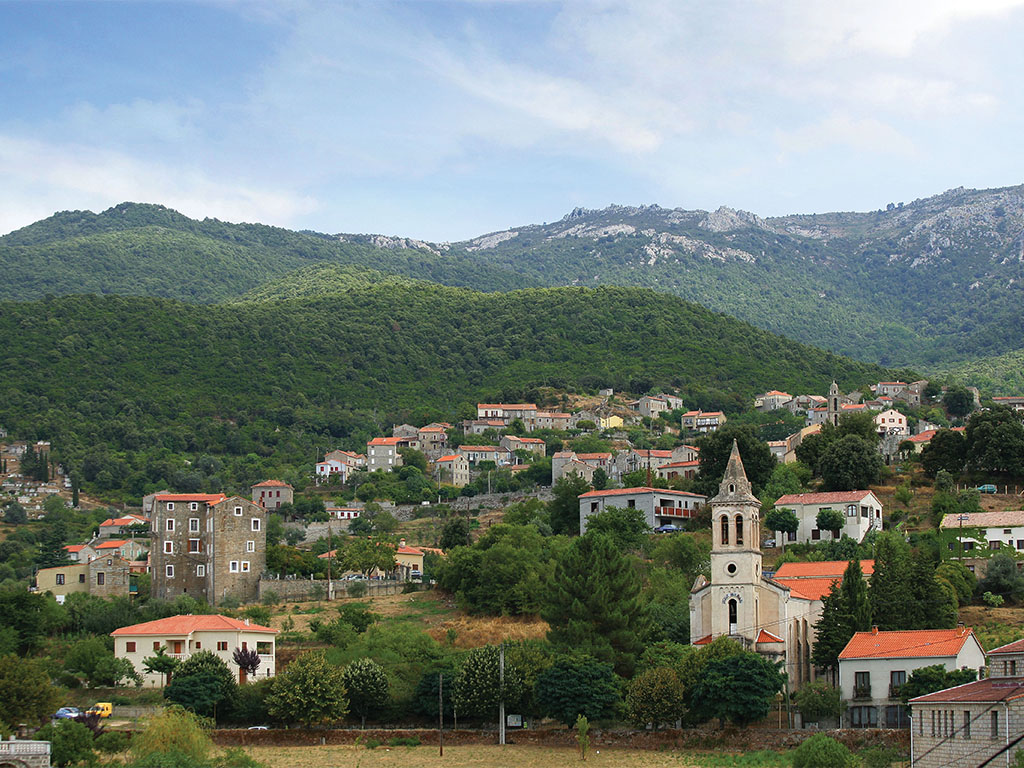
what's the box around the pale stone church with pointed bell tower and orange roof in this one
[690,441,873,690]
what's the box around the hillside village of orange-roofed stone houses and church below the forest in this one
[6,370,1024,766]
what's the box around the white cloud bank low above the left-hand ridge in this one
[0,134,316,231]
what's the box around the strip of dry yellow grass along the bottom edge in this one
[247,745,699,768]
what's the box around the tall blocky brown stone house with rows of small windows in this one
[150,494,267,605]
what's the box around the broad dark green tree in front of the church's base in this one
[691,651,785,727]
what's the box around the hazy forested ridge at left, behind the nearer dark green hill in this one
[0,203,538,302]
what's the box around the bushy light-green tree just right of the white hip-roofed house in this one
[267,651,348,728]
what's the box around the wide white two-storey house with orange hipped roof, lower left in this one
[111,614,278,687]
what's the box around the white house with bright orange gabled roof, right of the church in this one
[839,627,985,728]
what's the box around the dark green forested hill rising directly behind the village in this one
[0,282,892,505]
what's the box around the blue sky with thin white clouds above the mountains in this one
[0,0,1024,242]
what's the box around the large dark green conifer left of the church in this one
[541,536,648,676]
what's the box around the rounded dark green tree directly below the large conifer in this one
[534,655,620,726]
